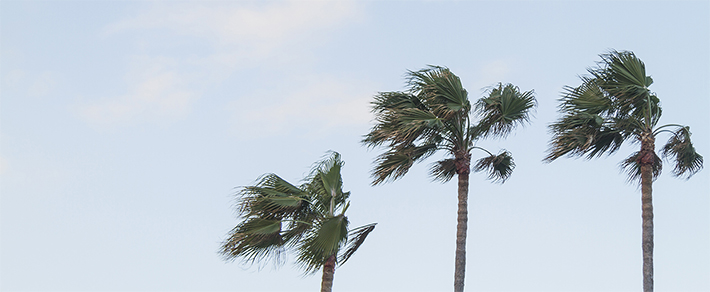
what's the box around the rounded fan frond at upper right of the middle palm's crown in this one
[476,83,537,137]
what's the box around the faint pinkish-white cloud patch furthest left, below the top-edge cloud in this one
[80,57,195,124]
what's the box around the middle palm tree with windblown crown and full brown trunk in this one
[362,66,536,291]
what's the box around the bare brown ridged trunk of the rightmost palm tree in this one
[639,133,656,292]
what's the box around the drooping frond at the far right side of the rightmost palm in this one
[661,127,703,179]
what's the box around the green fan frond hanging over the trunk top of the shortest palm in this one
[297,215,349,273]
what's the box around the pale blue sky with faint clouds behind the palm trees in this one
[0,1,710,291]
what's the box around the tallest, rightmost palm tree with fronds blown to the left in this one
[545,51,703,292]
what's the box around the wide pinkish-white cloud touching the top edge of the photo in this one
[107,1,357,56]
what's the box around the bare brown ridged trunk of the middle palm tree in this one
[454,153,471,292]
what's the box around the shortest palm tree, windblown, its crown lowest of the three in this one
[220,152,376,292]
